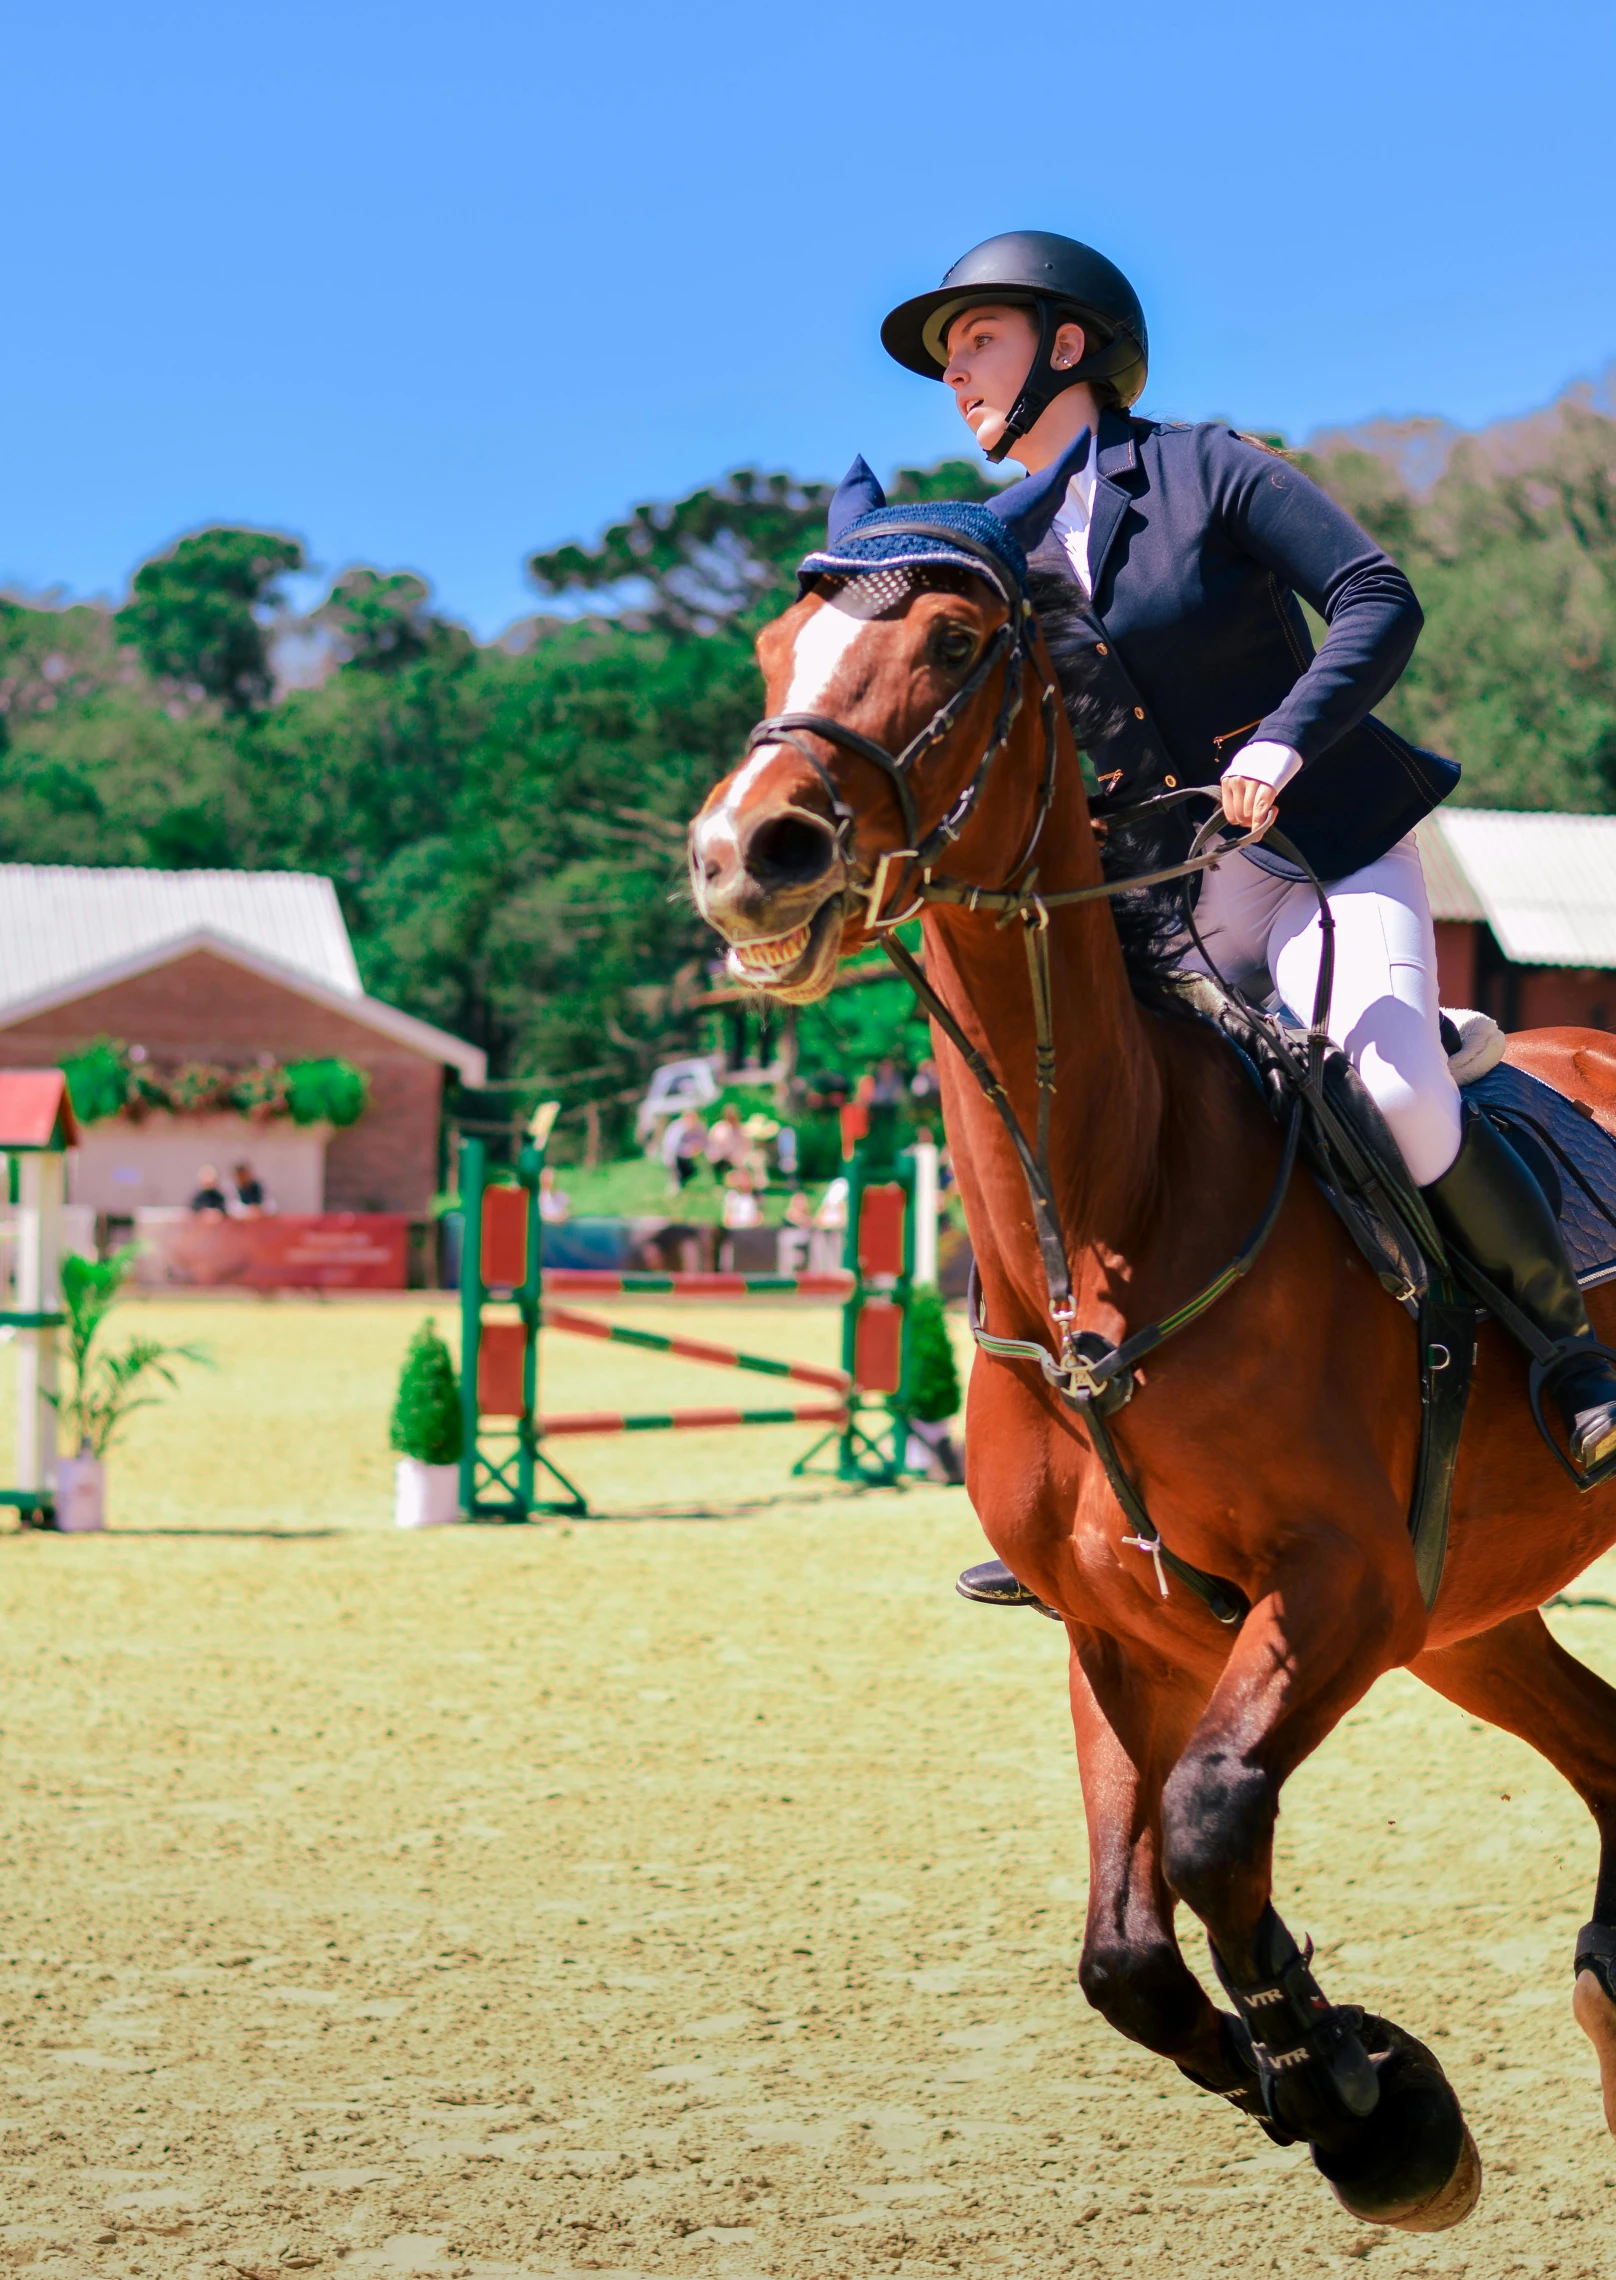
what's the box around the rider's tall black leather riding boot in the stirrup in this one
[1420,1108,1616,1473]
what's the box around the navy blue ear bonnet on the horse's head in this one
[798,429,1089,600]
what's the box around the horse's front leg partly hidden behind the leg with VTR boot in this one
[1071,1626,1288,2143]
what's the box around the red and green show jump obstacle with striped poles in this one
[460,1110,937,1521]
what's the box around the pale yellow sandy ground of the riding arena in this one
[0,1304,1616,2280]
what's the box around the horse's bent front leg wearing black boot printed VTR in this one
[1162,1525,1482,2232]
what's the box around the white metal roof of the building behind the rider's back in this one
[1420,807,1616,969]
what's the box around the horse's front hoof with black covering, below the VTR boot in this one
[1313,2018,1482,2232]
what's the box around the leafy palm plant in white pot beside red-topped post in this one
[46,1243,210,1534]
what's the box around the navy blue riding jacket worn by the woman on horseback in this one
[1033,410,1459,878]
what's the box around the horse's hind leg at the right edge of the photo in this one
[1411,1610,1616,2136]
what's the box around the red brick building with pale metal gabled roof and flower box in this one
[0,864,488,1213]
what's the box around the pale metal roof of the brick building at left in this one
[0,862,365,1015]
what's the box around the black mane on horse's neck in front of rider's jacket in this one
[1028,568,1183,1008]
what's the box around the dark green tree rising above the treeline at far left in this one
[116,529,303,714]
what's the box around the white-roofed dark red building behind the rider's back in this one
[1420,807,1616,1028]
